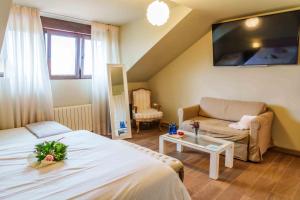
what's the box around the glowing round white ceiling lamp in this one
[147,0,170,26]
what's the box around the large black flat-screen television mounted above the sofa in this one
[212,10,300,66]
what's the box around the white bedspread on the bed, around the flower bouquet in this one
[0,131,190,200]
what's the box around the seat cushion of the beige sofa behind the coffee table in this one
[180,116,249,142]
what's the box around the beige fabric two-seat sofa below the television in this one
[178,97,273,162]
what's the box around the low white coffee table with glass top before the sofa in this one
[159,131,234,179]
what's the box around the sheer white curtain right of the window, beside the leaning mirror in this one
[92,23,120,135]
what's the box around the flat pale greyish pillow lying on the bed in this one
[25,121,72,138]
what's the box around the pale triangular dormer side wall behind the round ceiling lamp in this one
[120,5,191,69]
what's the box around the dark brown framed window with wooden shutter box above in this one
[42,17,92,79]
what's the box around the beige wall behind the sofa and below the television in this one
[149,32,300,150]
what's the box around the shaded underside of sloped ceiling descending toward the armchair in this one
[127,10,213,82]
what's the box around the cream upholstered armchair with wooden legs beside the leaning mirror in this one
[132,88,163,133]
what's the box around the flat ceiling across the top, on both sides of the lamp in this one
[14,0,300,25]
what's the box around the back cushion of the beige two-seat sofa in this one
[199,97,267,121]
